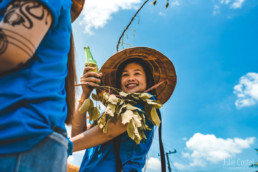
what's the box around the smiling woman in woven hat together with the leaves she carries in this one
[71,47,176,172]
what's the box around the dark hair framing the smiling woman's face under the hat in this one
[116,58,155,95]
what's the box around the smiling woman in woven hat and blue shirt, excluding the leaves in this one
[71,47,176,172]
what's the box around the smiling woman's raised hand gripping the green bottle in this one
[80,66,102,97]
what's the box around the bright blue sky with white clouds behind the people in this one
[69,0,258,172]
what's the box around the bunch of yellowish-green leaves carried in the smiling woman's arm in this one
[80,88,162,144]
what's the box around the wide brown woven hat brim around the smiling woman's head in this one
[100,47,177,104]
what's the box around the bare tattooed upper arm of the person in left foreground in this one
[0,0,52,72]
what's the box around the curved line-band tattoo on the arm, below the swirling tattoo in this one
[0,29,36,57]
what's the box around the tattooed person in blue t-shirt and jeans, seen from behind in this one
[0,0,84,172]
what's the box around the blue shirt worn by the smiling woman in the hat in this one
[80,101,154,172]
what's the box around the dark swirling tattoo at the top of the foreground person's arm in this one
[3,0,50,29]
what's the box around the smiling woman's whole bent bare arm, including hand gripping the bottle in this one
[71,67,126,152]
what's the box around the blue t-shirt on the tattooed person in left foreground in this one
[0,0,72,154]
